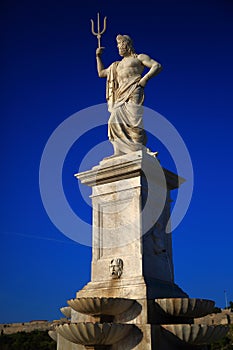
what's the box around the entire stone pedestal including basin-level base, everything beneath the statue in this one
[53,151,225,350]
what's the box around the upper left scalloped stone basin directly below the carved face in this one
[67,298,135,316]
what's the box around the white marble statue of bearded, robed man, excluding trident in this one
[96,35,162,156]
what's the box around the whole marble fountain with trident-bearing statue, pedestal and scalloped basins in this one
[48,16,228,350]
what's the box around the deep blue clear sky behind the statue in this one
[0,0,233,323]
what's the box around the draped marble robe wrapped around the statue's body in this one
[106,62,146,153]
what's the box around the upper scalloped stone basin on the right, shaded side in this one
[155,298,215,318]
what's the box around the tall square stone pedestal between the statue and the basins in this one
[76,151,187,299]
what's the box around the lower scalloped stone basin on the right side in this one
[161,324,229,345]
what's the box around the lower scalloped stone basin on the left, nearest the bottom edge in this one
[56,322,134,346]
